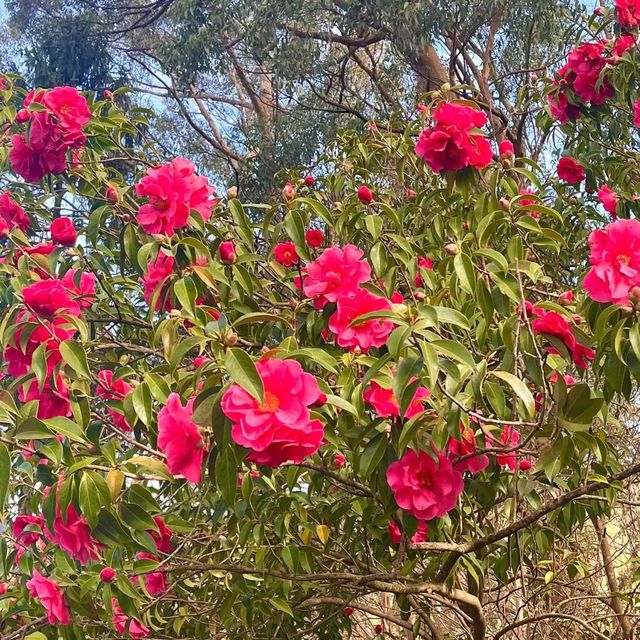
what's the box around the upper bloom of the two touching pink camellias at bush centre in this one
[303,244,371,308]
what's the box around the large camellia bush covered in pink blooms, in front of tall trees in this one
[5,5,640,640]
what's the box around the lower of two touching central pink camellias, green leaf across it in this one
[329,289,393,352]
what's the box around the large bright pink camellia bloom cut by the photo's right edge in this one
[583,220,640,303]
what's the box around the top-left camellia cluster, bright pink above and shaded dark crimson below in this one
[9,87,91,182]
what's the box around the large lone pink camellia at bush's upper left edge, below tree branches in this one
[136,158,217,236]
